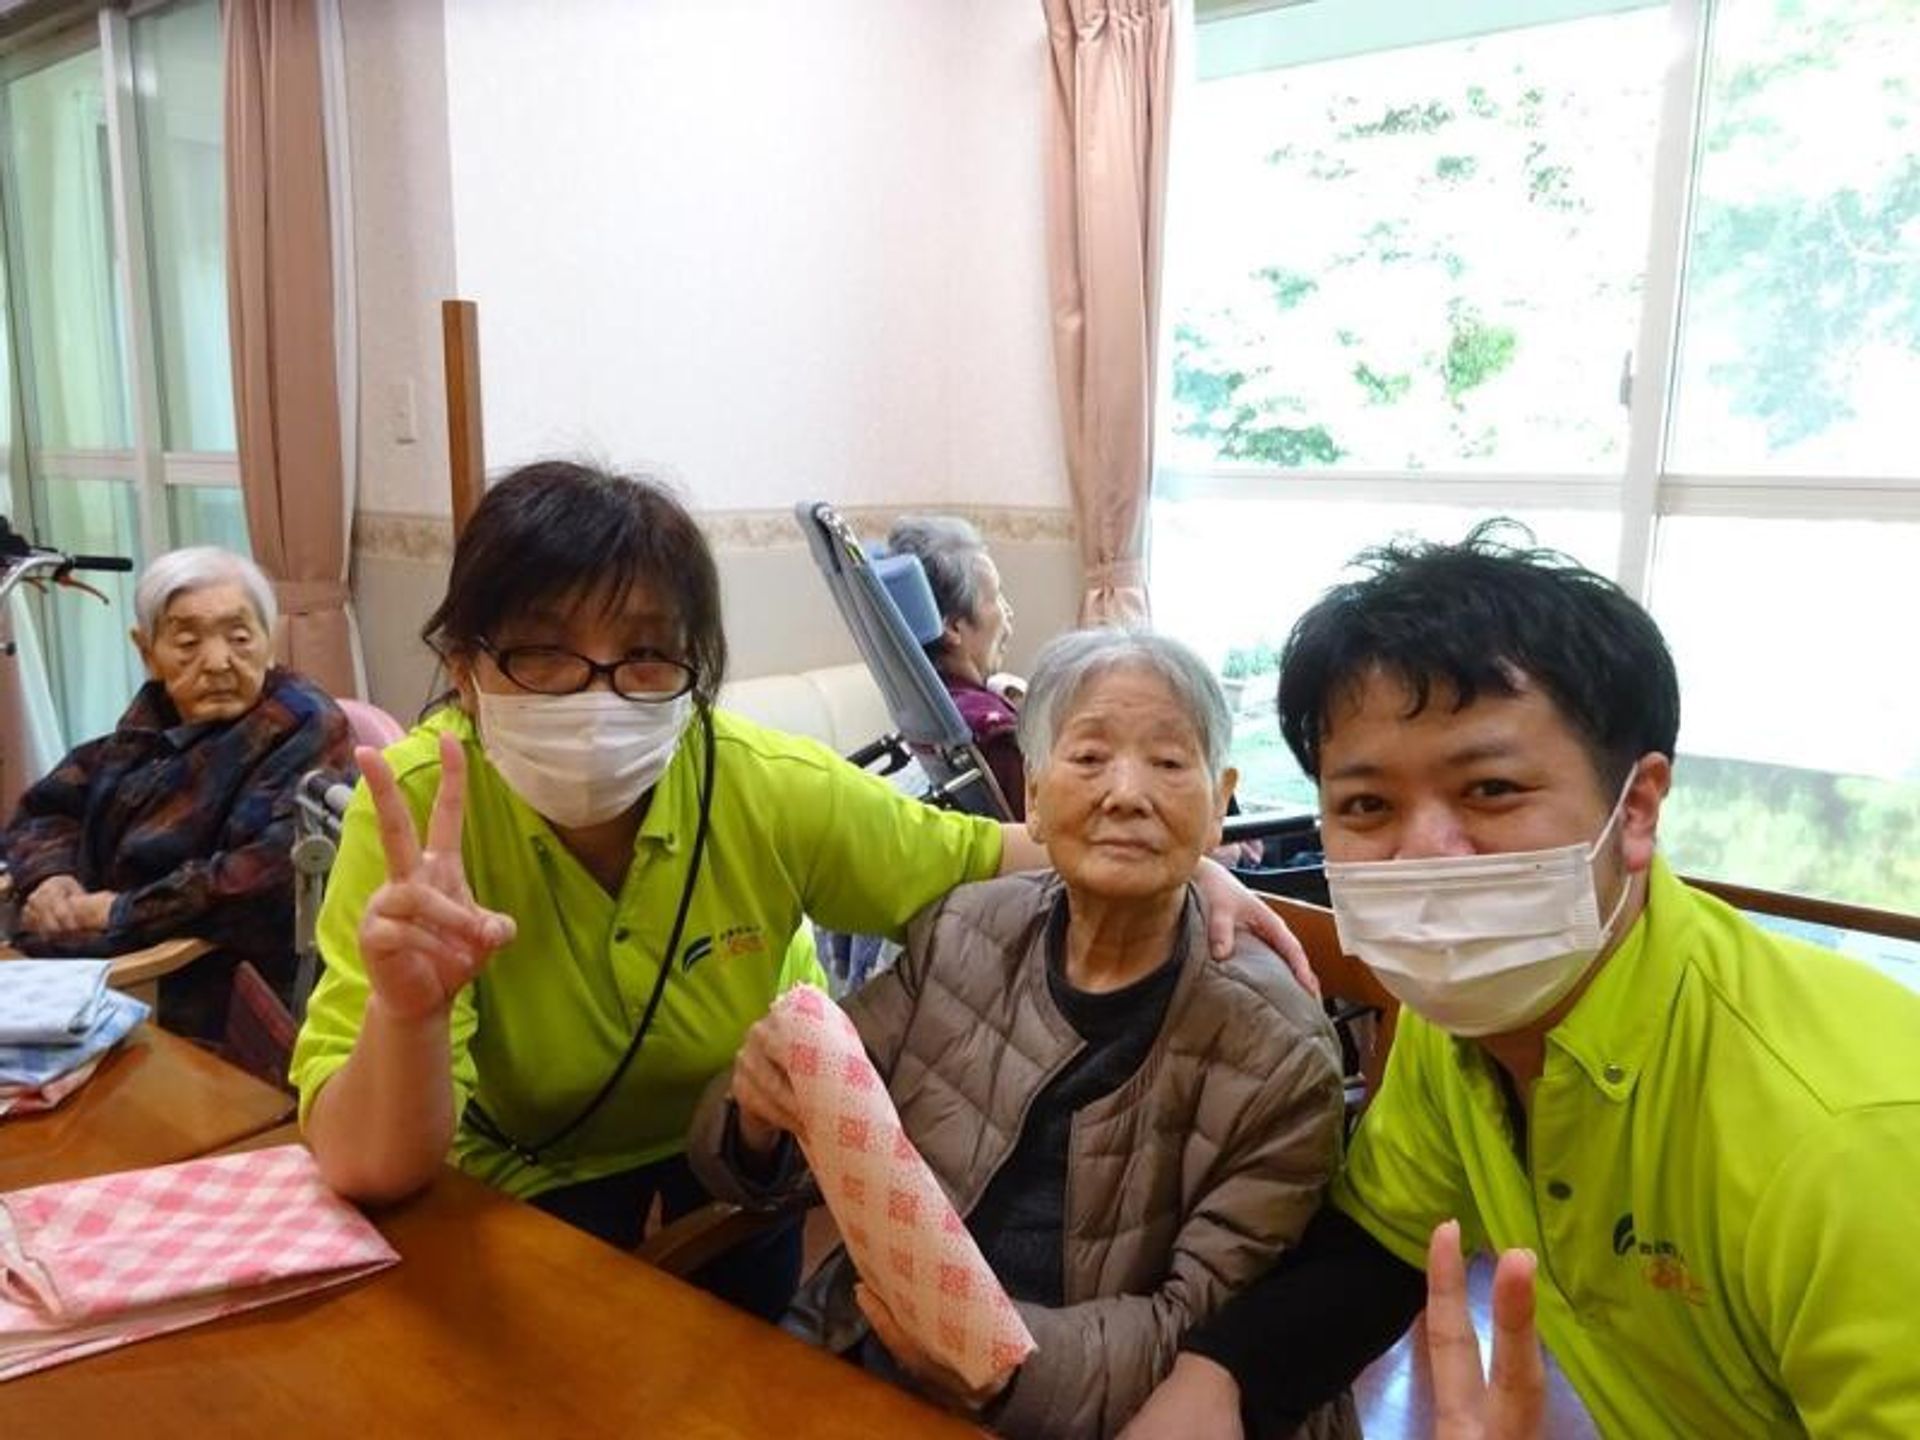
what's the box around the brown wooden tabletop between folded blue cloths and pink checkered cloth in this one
[0,1025,294,1190]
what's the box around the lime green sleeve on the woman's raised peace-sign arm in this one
[290,766,478,1125]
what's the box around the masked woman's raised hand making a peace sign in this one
[353,733,515,1020]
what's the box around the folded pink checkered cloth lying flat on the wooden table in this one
[0,1144,399,1380]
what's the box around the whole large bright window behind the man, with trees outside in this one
[1152,0,1920,910]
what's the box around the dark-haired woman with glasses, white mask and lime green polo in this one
[292,461,1304,1313]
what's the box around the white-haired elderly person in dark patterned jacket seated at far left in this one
[6,545,351,1039]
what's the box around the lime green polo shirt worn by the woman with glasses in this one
[292,708,1000,1196]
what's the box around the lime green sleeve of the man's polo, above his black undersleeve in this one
[1332,1010,1484,1271]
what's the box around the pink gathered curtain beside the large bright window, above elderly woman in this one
[1043,0,1173,624]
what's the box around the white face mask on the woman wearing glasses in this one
[476,689,693,829]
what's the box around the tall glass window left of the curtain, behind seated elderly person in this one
[0,0,246,741]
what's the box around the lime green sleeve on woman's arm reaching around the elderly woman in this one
[787,756,1000,941]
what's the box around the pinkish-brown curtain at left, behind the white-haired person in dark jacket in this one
[223,0,357,695]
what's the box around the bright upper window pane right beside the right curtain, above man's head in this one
[1169,10,1663,474]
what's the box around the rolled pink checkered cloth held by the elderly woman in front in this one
[772,985,1033,1386]
